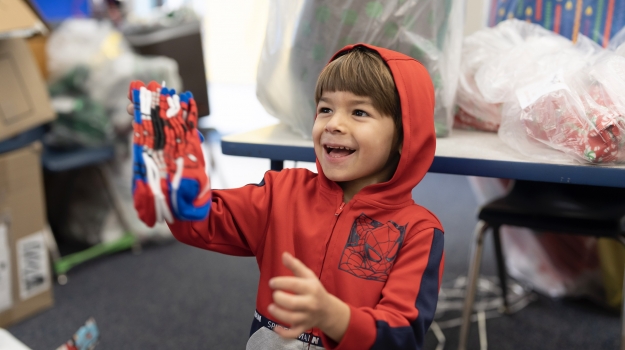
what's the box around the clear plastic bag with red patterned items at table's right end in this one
[499,52,625,163]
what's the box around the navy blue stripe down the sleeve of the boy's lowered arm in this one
[371,229,444,350]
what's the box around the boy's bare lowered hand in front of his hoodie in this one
[269,252,350,342]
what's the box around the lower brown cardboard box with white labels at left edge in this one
[0,142,53,327]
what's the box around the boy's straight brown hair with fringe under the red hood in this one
[315,46,404,146]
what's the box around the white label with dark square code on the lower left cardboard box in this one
[16,231,51,300]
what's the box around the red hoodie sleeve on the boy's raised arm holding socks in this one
[168,171,278,256]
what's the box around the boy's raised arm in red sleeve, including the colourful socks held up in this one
[128,81,271,255]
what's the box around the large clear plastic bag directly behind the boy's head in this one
[256,0,464,138]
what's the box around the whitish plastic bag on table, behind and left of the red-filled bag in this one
[456,19,573,131]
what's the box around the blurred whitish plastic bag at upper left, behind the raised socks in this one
[46,19,182,137]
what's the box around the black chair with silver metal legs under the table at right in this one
[458,180,625,350]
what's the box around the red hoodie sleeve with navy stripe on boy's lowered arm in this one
[322,228,444,350]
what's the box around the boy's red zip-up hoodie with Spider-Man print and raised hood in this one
[170,45,444,349]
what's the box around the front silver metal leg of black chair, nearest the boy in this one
[458,220,488,350]
